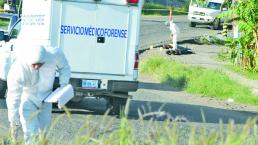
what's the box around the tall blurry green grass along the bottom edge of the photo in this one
[0,115,258,145]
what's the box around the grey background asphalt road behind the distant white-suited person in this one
[140,16,220,50]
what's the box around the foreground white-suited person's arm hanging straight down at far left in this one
[6,63,24,125]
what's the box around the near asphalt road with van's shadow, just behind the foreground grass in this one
[0,96,258,145]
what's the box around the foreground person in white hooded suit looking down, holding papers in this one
[6,45,71,144]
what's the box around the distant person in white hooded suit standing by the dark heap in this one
[169,10,181,54]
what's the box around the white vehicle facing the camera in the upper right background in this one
[188,0,230,30]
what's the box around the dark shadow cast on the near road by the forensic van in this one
[0,98,258,124]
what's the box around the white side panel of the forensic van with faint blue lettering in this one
[19,0,52,40]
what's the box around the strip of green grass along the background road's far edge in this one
[142,2,188,16]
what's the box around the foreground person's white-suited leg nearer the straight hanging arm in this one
[19,99,40,145]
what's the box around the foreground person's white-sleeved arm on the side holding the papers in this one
[57,50,71,87]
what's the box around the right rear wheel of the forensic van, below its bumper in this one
[107,97,128,115]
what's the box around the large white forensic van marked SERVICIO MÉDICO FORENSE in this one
[0,0,144,113]
